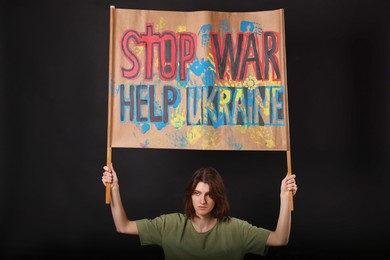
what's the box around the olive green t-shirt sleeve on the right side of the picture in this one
[240,221,271,256]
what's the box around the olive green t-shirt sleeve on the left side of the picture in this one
[136,215,166,246]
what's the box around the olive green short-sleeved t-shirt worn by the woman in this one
[136,213,270,260]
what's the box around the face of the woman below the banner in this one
[192,182,215,217]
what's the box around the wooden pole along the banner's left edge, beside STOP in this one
[106,5,115,204]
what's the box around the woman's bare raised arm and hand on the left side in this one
[102,166,138,235]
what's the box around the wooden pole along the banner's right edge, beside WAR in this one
[281,9,294,211]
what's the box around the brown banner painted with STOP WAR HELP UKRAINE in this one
[108,7,289,150]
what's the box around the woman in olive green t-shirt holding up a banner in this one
[102,166,298,260]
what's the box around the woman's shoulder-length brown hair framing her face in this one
[184,167,230,221]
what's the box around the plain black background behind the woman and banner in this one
[0,0,390,259]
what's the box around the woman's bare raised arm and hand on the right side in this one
[267,174,298,246]
